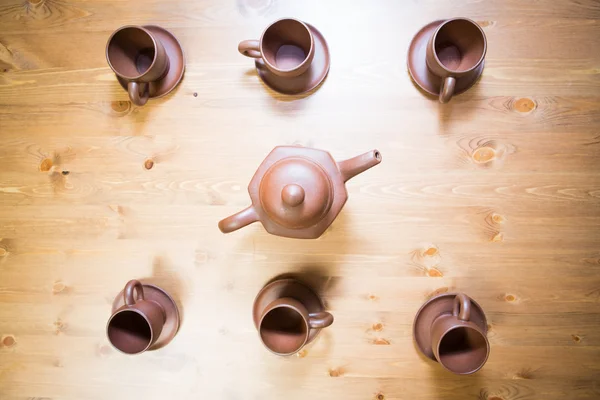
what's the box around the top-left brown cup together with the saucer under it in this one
[106,25,185,106]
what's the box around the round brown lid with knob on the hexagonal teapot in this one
[259,157,333,229]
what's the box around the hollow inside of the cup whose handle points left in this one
[261,19,312,71]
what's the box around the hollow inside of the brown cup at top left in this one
[106,27,156,79]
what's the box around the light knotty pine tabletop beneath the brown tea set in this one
[0,0,600,400]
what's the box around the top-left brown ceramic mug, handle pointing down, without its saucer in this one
[106,26,169,106]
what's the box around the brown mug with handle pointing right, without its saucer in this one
[258,297,333,356]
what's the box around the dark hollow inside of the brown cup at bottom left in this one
[107,310,152,354]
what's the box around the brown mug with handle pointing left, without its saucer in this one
[238,18,315,78]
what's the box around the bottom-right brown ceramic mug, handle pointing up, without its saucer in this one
[431,293,490,375]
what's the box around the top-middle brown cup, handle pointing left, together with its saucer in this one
[238,18,330,94]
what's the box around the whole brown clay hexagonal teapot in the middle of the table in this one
[219,146,381,239]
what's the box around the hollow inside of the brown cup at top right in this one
[434,19,485,72]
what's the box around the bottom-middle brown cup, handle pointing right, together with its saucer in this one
[252,279,333,355]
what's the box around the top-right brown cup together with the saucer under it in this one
[407,18,487,103]
